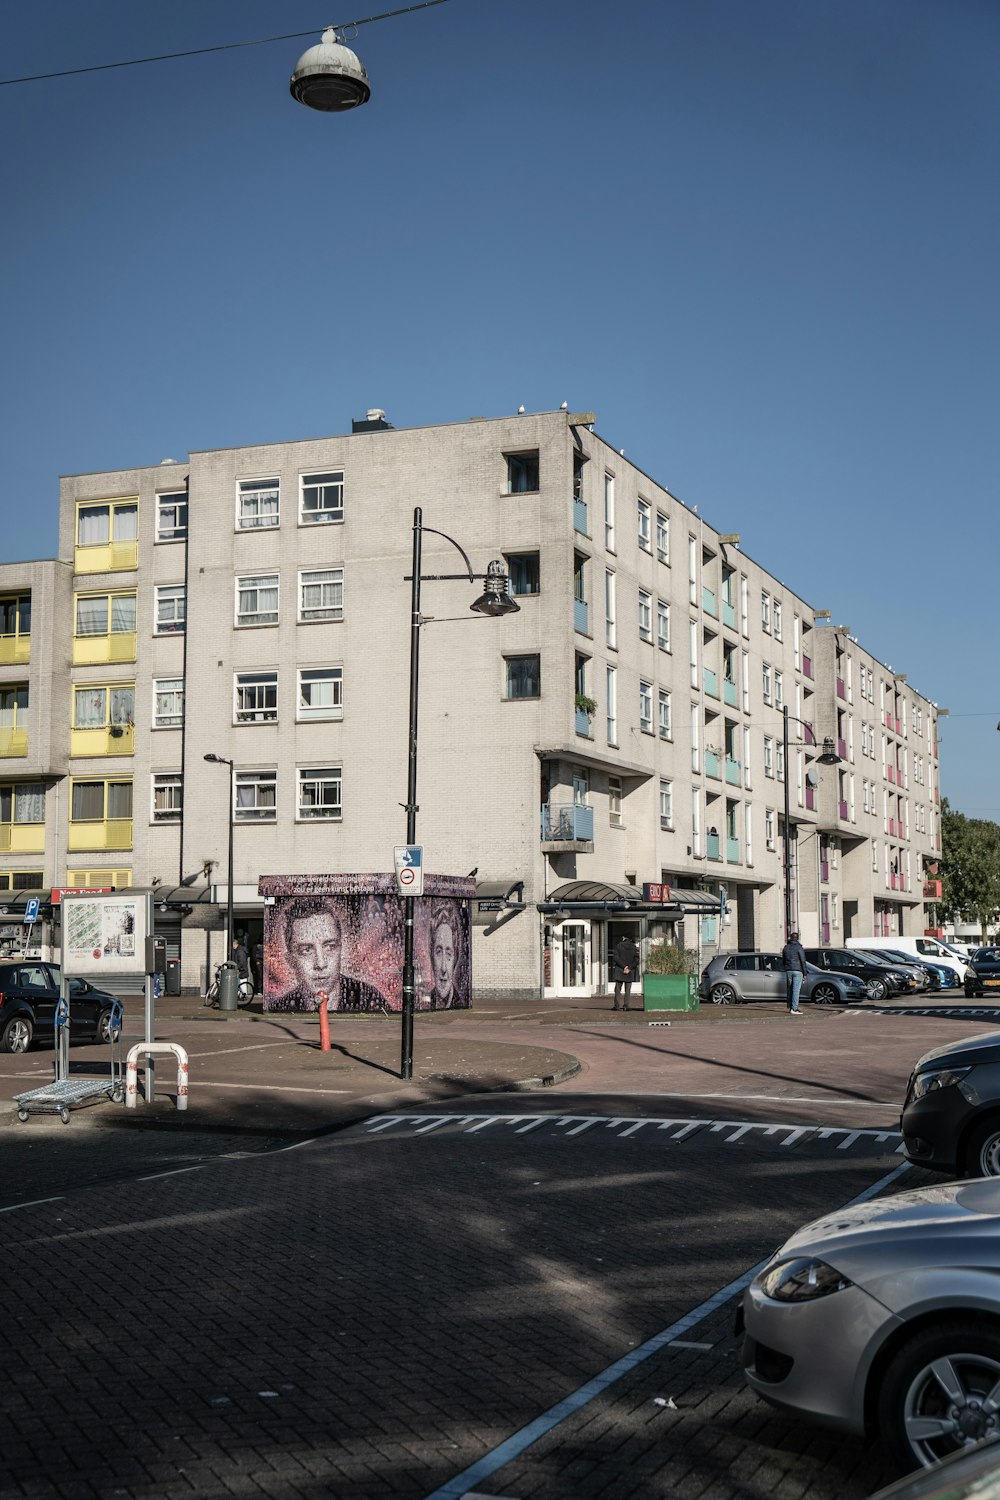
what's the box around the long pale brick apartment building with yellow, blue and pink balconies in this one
[0,411,939,996]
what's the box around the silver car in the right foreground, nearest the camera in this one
[742,1182,1000,1470]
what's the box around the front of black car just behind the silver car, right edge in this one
[900,1032,1000,1178]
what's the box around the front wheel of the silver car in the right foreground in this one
[879,1320,1000,1473]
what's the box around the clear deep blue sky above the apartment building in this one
[0,0,1000,821]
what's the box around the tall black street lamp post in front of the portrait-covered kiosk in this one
[399,506,520,1079]
